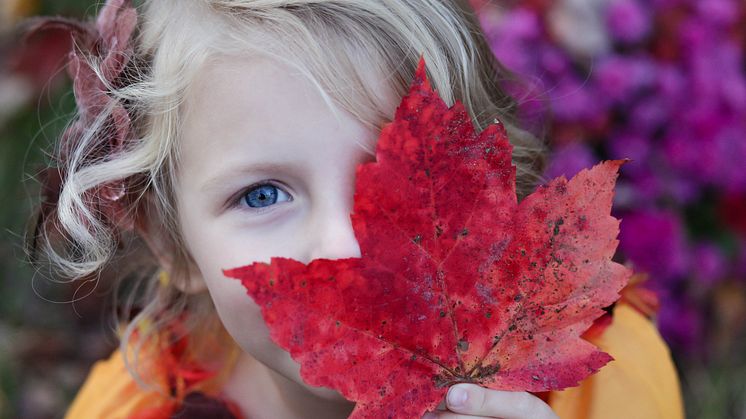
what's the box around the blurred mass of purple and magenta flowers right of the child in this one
[473,0,746,355]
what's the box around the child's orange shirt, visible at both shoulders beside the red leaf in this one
[65,301,684,419]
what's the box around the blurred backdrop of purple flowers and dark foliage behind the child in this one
[0,0,746,418]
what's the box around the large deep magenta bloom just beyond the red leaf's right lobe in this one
[619,210,688,283]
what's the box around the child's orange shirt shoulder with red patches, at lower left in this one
[65,326,241,419]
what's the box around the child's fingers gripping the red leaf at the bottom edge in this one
[423,383,558,419]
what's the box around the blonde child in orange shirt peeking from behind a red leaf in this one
[27,0,682,419]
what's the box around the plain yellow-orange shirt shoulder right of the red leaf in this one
[547,303,684,419]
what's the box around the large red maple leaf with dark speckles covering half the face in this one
[224,55,631,418]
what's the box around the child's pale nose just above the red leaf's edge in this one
[307,198,360,262]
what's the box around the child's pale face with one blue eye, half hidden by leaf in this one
[176,57,396,396]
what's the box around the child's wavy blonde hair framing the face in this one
[27,0,545,398]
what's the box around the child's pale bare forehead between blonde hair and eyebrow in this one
[178,56,377,183]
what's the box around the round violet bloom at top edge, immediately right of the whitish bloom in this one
[606,0,652,43]
